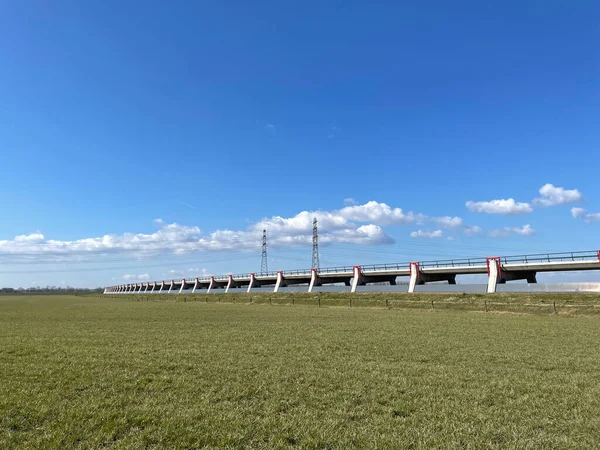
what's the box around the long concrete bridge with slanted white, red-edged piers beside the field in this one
[104,250,600,294]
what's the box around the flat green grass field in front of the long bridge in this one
[0,294,600,449]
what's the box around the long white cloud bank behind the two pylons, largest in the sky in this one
[0,201,464,261]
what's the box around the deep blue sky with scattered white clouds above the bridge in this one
[0,1,600,287]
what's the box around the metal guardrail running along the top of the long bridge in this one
[109,250,600,287]
